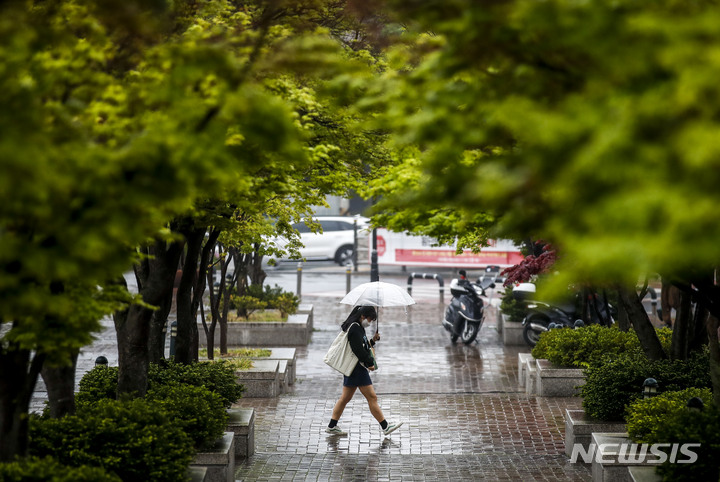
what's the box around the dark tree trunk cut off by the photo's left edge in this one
[0,344,45,462]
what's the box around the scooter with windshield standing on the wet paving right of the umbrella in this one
[442,270,495,345]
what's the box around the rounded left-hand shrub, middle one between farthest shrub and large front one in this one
[145,383,228,449]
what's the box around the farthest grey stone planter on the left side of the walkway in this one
[198,314,312,346]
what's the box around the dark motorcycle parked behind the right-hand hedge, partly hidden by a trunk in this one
[523,286,614,347]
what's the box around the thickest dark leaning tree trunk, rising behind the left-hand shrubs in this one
[114,241,183,397]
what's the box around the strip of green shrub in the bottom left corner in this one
[0,457,121,482]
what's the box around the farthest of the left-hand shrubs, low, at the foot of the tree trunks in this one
[148,360,245,408]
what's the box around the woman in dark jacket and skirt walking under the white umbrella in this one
[325,306,403,436]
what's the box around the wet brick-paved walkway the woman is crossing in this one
[236,297,591,481]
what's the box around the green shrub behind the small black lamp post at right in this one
[581,349,711,421]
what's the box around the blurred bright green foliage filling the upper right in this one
[374,0,720,284]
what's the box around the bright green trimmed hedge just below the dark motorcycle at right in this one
[532,325,672,368]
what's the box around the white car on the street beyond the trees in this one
[272,216,370,266]
